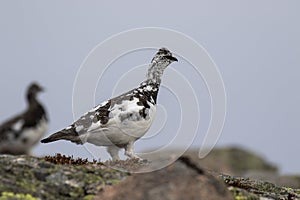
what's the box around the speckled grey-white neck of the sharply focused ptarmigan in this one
[146,62,164,85]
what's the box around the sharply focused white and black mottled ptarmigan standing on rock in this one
[41,48,178,160]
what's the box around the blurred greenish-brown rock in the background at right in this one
[185,147,300,188]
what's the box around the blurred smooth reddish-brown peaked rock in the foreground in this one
[96,157,233,200]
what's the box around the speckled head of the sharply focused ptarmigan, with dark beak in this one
[151,47,178,68]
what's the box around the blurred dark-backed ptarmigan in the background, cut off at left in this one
[0,83,48,155]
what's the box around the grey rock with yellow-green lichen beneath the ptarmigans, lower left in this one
[0,155,128,199]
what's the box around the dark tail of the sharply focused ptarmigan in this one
[41,129,82,144]
